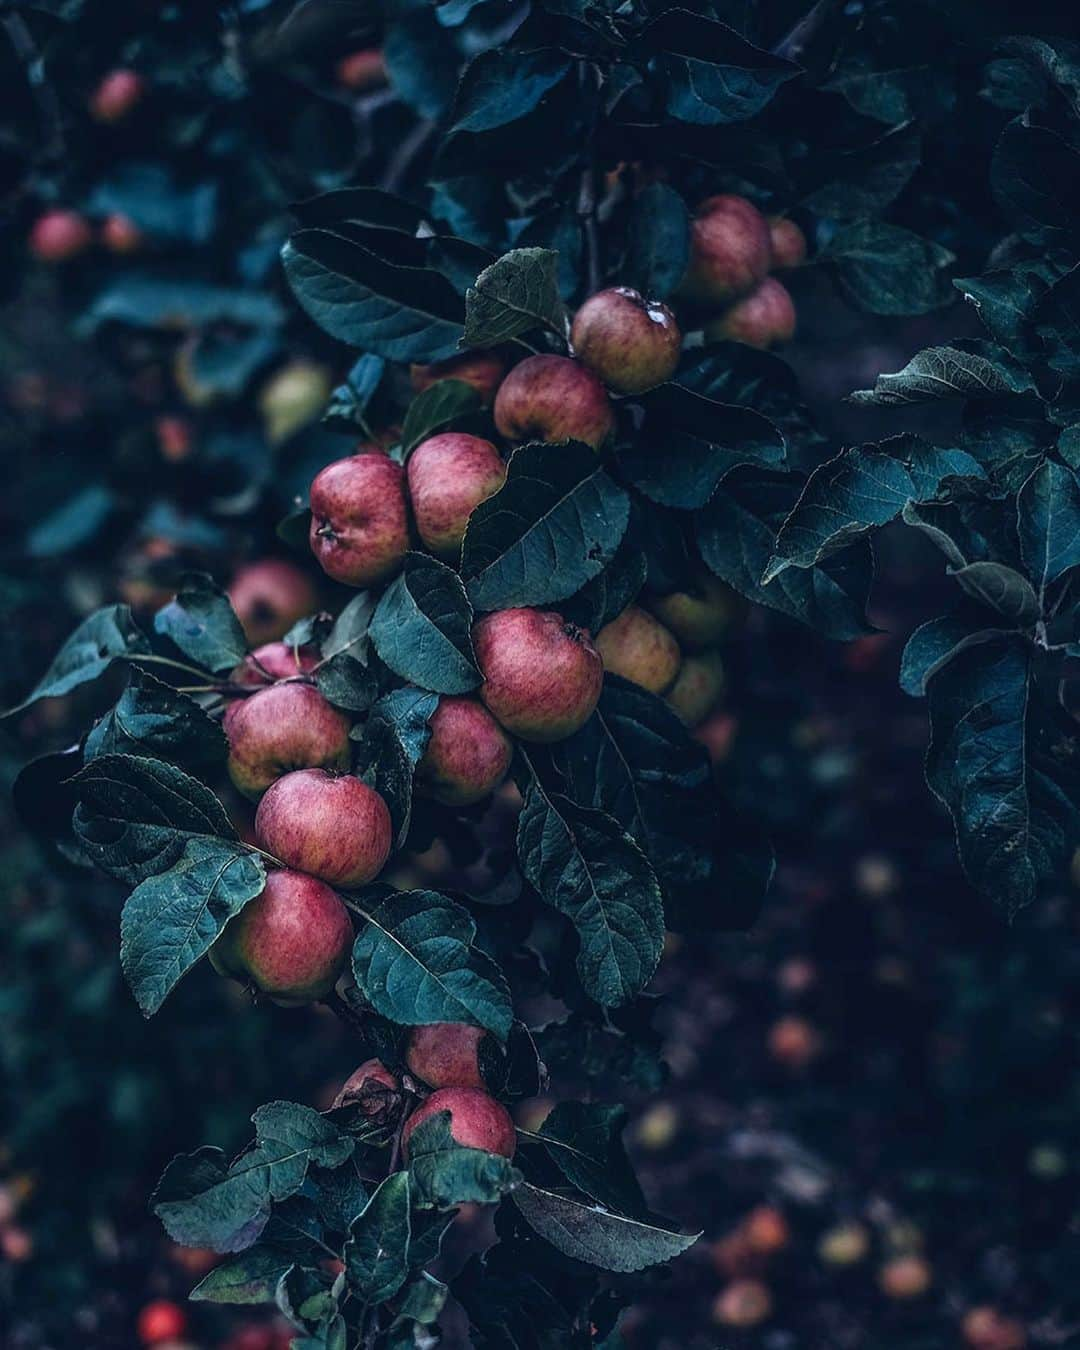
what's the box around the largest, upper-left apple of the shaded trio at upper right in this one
[679,193,772,305]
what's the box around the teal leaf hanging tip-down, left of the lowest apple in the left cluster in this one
[120,838,266,1017]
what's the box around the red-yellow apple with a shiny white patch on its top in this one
[570,286,683,394]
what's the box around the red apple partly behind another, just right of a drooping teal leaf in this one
[209,868,352,1007]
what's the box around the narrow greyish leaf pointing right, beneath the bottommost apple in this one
[513,1183,701,1274]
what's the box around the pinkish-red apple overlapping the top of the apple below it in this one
[255,768,394,887]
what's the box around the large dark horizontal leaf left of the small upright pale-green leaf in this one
[282,230,463,362]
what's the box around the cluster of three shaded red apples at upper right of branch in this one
[678,193,806,350]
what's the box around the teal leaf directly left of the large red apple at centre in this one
[371,554,482,694]
